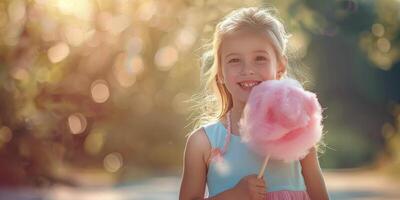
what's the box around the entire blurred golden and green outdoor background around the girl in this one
[0,0,400,199]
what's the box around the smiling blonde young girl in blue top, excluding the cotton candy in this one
[179,8,328,200]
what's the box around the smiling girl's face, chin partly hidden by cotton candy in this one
[218,31,286,103]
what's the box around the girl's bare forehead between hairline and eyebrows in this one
[220,31,274,56]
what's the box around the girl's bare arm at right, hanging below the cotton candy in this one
[300,148,329,200]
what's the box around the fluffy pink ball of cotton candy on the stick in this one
[239,79,322,162]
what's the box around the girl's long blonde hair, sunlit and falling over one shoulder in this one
[194,7,298,129]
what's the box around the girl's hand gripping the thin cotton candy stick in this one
[233,174,266,200]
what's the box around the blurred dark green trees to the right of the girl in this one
[276,0,400,167]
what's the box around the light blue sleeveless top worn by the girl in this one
[203,121,306,197]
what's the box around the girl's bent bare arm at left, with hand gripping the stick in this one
[179,129,265,200]
